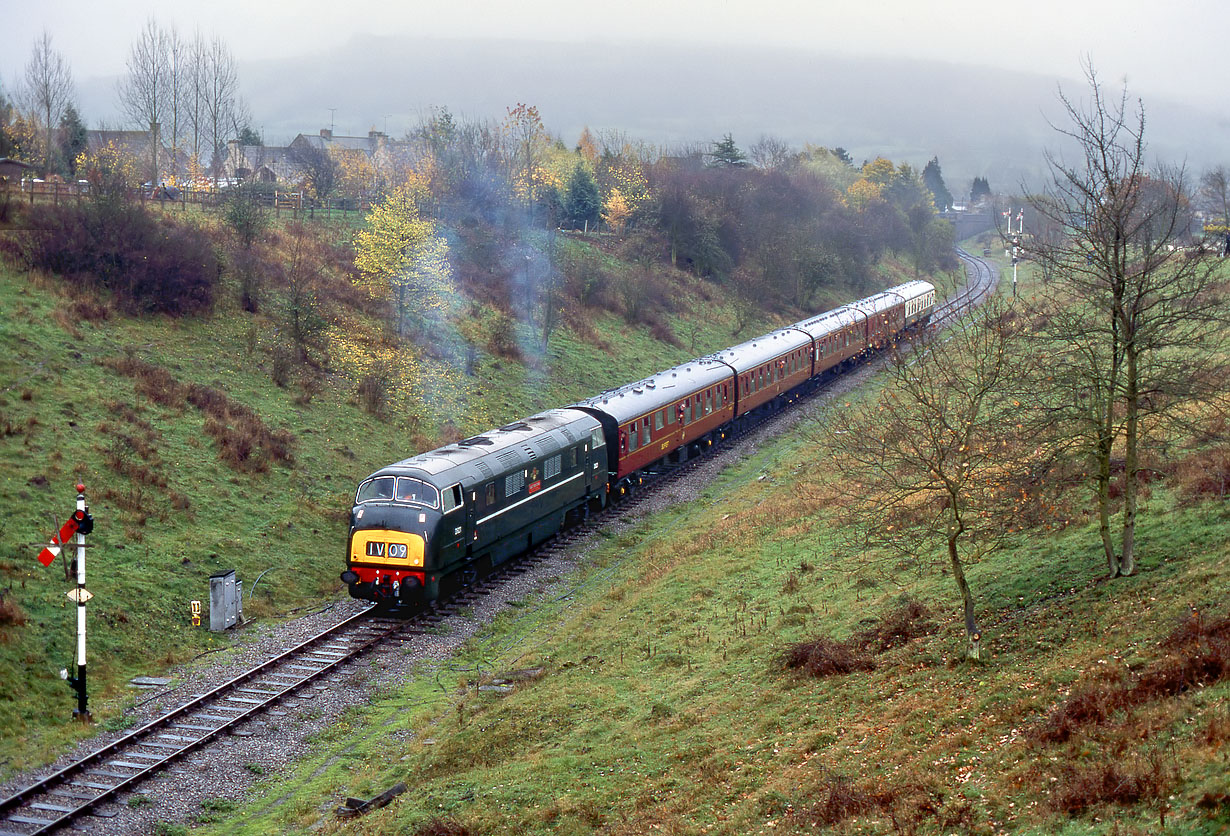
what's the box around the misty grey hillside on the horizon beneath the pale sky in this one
[223,37,1230,194]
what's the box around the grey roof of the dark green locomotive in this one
[373,407,600,487]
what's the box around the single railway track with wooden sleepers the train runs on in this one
[0,250,998,836]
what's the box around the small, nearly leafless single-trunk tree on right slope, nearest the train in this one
[827,300,1032,658]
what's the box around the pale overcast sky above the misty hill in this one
[0,0,1230,111]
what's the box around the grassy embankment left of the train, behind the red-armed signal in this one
[0,207,915,776]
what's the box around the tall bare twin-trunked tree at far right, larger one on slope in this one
[1030,66,1225,575]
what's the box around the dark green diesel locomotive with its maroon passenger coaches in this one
[341,280,936,607]
